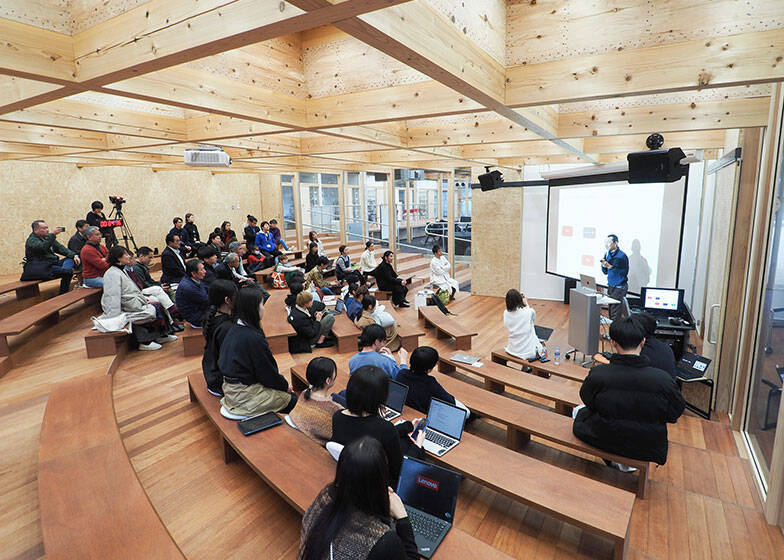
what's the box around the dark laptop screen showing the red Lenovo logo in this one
[397,457,460,523]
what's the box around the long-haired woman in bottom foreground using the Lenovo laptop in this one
[299,437,419,560]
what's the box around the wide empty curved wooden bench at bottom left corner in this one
[38,376,185,560]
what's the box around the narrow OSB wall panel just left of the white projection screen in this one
[471,172,523,297]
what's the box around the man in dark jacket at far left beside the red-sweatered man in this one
[21,220,81,294]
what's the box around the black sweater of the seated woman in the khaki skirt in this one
[218,323,289,391]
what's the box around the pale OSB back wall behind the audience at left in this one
[0,161,270,274]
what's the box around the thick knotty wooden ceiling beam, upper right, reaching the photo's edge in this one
[506,27,784,107]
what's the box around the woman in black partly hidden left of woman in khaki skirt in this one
[201,280,237,397]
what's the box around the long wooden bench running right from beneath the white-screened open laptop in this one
[291,364,634,560]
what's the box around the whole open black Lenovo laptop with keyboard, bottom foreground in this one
[397,457,461,558]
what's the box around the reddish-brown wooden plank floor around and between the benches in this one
[0,284,784,560]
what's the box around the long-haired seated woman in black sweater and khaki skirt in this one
[218,288,297,416]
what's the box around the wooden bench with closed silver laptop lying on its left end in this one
[438,356,582,417]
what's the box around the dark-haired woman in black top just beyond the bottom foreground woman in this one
[332,366,425,488]
